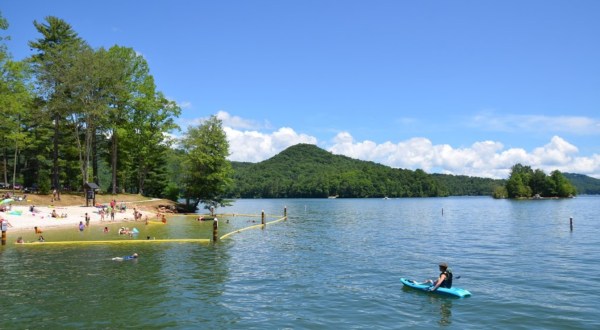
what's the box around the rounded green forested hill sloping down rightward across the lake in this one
[229,144,504,198]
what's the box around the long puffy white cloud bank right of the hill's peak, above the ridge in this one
[329,132,600,178]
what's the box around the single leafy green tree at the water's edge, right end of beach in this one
[182,116,232,210]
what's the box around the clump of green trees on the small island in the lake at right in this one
[506,164,576,198]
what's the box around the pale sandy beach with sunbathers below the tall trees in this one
[0,203,156,231]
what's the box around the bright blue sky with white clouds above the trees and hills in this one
[0,0,600,178]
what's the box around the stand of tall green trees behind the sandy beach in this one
[0,16,180,197]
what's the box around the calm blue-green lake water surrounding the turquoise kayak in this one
[0,196,600,329]
